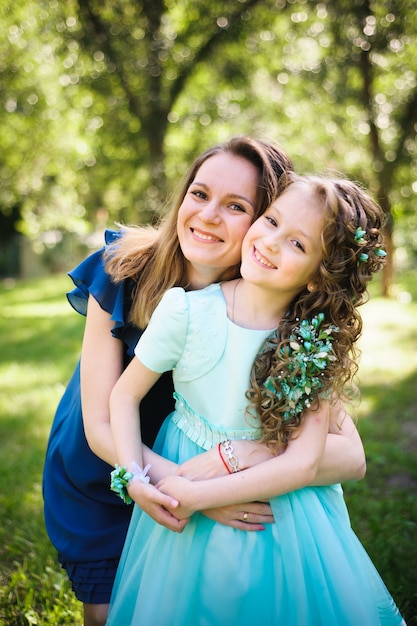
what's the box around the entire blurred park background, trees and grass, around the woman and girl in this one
[0,0,417,626]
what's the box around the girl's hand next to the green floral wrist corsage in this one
[128,480,189,533]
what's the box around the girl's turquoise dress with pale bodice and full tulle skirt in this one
[107,285,404,626]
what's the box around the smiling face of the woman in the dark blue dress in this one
[177,152,258,287]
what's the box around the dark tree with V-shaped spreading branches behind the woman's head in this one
[69,0,270,210]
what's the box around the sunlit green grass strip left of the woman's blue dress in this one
[0,276,83,626]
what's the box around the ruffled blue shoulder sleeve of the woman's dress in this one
[67,230,139,345]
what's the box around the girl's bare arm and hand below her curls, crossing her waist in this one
[157,401,329,518]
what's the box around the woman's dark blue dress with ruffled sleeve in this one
[43,231,174,603]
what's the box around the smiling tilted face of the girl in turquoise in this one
[241,183,324,301]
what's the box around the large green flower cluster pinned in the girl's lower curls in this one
[264,313,339,422]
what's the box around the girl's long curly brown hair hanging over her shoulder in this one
[247,174,385,447]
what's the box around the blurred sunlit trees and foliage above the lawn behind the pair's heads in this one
[0,0,417,293]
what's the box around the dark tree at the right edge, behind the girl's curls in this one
[316,0,417,295]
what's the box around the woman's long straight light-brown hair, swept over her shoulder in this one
[105,136,293,328]
